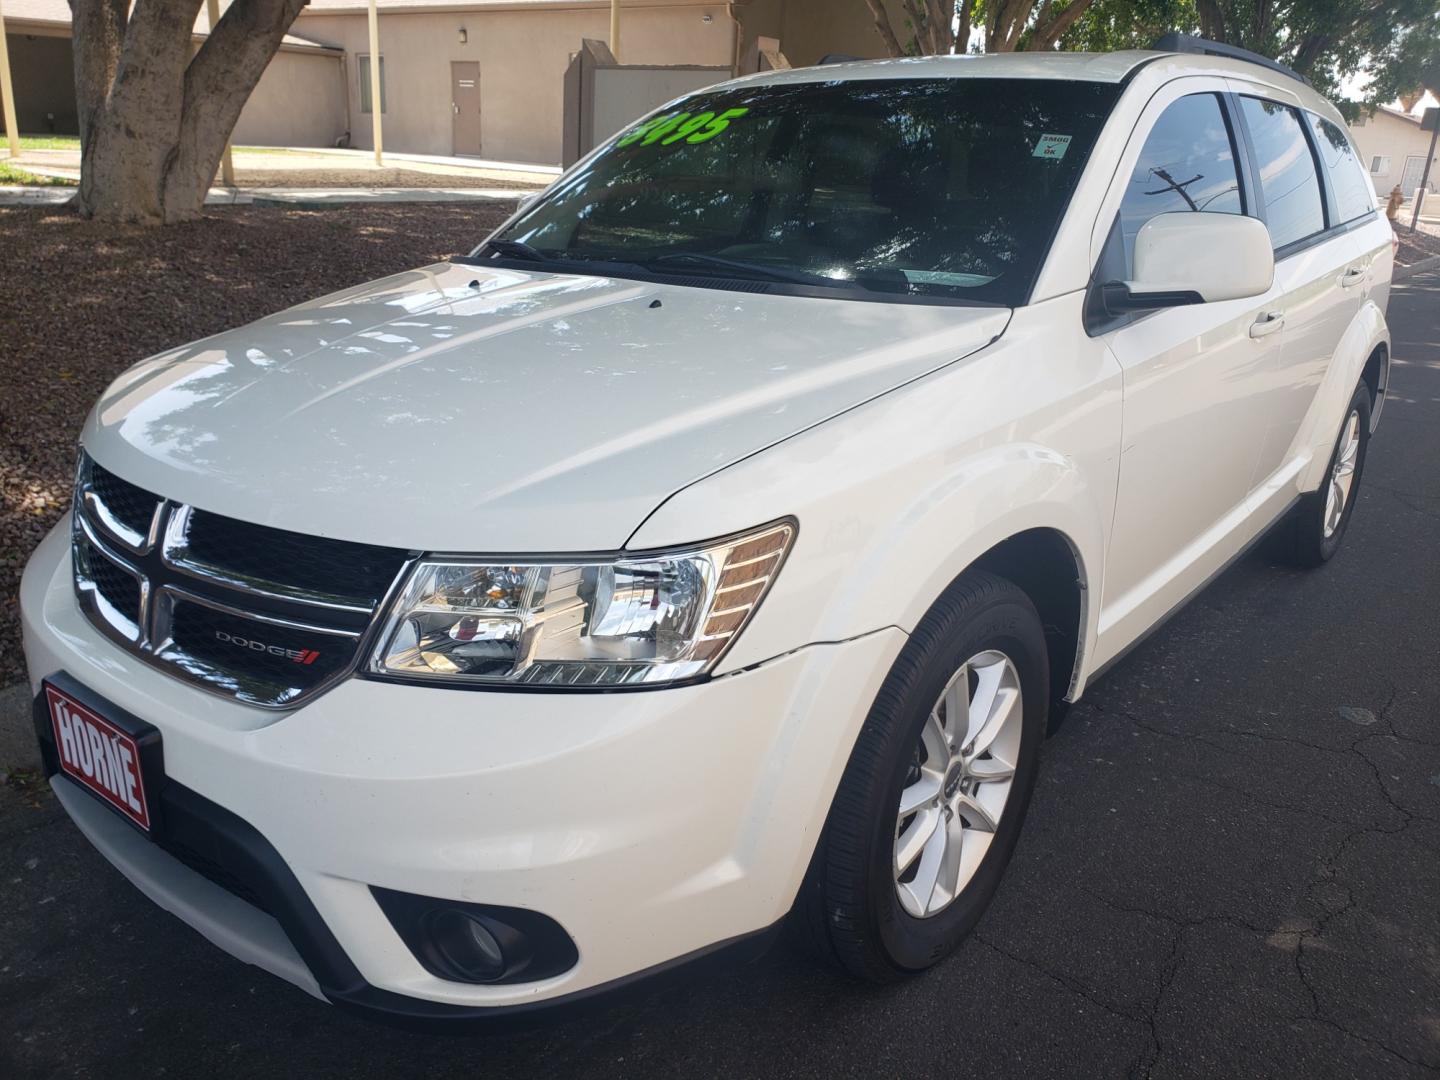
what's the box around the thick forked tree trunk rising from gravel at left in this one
[71,0,305,225]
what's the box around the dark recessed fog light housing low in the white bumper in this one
[370,887,579,985]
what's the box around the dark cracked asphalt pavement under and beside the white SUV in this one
[0,274,1440,1080]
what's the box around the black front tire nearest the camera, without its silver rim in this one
[792,572,1050,982]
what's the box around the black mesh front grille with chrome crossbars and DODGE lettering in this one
[72,458,410,708]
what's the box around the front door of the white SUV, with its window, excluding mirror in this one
[1097,92,1283,649]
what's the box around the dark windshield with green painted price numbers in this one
[482,78,1117,305]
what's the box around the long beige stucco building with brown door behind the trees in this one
[4,0,898,164]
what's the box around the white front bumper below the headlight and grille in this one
[22,526,904,1020]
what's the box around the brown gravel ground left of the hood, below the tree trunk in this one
[0,203,510,687]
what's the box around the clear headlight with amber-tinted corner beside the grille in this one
[370,523,795,687]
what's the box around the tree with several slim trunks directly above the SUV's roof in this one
[865,0,1093,56]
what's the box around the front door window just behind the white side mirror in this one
[1116,94,1244,278]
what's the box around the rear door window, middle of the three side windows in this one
[1240,98,1325,251]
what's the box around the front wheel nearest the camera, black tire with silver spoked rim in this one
[796,572,1050,981]
